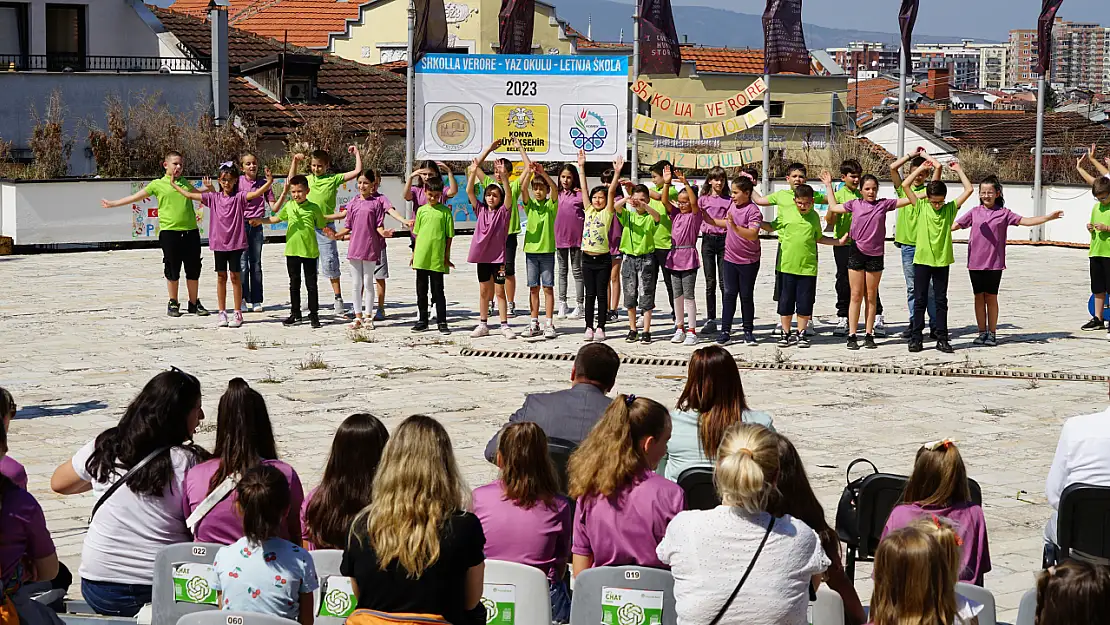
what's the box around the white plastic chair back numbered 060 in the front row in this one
[482,560,552,625]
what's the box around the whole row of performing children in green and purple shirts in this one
[102,141,1110,353]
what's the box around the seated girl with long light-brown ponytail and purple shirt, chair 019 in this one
[567,395,685,575]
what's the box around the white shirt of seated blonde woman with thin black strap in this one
[656,505,830,625]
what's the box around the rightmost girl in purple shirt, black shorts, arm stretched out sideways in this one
[952,175,1063,347]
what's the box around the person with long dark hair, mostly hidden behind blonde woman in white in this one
[768,434,867,625]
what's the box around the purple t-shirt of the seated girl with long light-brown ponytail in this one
[571,471,686,568]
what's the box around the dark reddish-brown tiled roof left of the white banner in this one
[151,7,405,138]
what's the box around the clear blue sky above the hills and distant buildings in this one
[673,0,1110,41]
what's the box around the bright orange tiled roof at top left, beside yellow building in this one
[164,0,365,49]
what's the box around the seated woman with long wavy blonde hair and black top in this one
[340,415,486,625]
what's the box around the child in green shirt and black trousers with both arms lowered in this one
[413,177,455,334]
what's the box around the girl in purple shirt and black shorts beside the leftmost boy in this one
[172,161,274,327]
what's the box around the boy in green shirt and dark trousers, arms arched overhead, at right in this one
[899,161,973,354]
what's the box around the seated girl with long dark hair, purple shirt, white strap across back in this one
[184,377,304,545]
